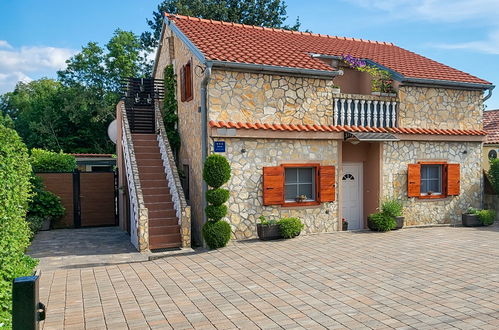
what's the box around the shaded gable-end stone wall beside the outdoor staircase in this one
[155,29,204,245]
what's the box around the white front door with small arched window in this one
[341,163,364,230]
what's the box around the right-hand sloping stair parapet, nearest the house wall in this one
[154,101,191,247]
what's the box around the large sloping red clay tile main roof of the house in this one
[169,14,490,84]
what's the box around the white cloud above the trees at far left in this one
[0,40,76,94]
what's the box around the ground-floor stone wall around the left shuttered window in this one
[210,138,339,239]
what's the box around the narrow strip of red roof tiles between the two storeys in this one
[209,120,486,136]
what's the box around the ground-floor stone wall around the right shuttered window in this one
[382,141,482,225]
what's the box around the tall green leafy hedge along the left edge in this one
[0,125,36,328]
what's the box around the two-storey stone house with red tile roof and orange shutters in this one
[154,14,494,243]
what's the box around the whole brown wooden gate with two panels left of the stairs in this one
[37,171,118,228]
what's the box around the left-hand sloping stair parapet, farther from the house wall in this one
[118,101,149,251]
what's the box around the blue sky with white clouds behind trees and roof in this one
[0,0,499,109]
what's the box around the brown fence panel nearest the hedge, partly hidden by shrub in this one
[36,173,74,228]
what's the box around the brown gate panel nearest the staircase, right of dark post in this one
[80,172,116,227]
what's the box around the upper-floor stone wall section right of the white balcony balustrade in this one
[399,86,483,129]
